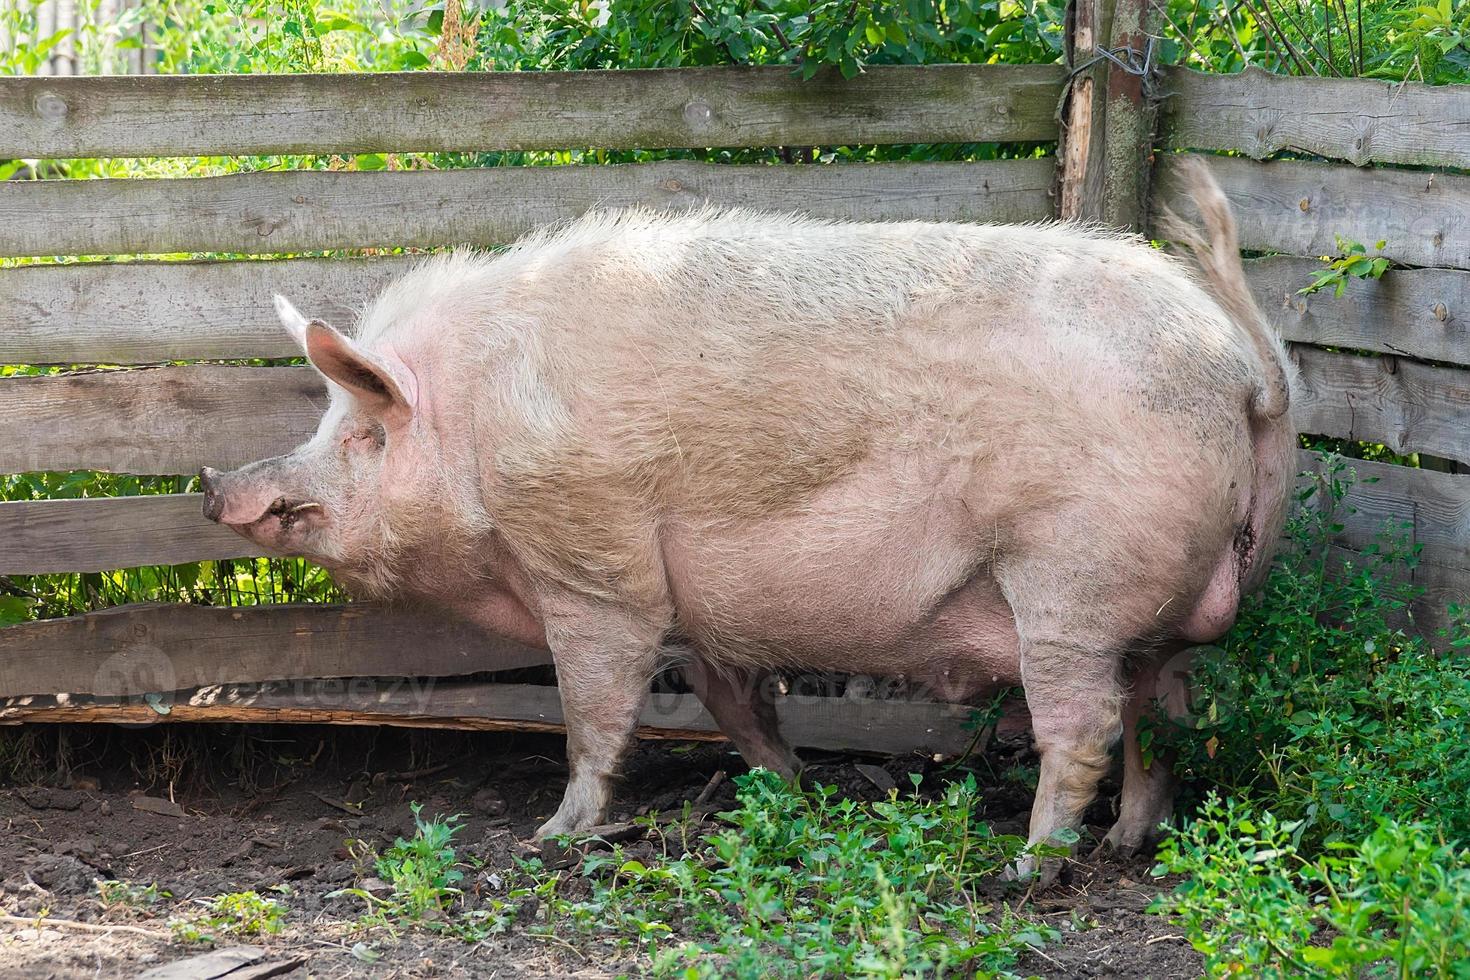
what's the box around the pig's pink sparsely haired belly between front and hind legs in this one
[664,487,1020,701]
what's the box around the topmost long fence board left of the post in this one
[0,65,1063,159]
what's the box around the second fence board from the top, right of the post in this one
[1152,154,1470,269]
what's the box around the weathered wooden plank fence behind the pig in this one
[0,36,1470,751]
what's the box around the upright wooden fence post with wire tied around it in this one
[1058,0,1157,231]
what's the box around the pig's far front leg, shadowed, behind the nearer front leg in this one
[681,658,801,779]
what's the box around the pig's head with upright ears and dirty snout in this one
[200,297,442,594]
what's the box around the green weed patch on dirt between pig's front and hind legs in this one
[525,770,1055,977]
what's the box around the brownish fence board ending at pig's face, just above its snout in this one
[0,364,326,475]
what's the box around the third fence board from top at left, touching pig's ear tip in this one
[0,256,402,364]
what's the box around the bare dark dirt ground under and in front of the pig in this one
[0,726,1200,980]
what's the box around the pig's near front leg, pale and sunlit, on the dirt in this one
[537,607,664,839]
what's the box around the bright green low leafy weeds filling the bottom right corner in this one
[1155,798,1470,979]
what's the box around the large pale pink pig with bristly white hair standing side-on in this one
[201,166,1297,874]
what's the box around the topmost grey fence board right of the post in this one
[1161,66,1470,167]
